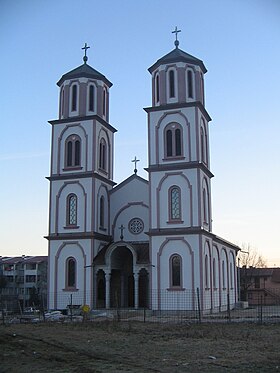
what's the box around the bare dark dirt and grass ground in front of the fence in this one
[0,322,280,373]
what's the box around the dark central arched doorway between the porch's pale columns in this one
[110,246,134,307]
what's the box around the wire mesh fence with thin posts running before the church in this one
[0,289,280,323]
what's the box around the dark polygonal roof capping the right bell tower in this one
[148,47,207,74]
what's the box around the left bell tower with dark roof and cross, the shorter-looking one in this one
[47,44,116,308]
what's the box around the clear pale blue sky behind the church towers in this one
[0,0,280,266]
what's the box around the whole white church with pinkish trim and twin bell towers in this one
[47,37,239,311]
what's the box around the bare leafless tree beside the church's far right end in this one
[237,243,267,301]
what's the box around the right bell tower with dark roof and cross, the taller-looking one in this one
[145,27,213,306]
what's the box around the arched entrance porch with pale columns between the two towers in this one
[93,241,149,308]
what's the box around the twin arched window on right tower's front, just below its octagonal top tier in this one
[165,123,183,158]
